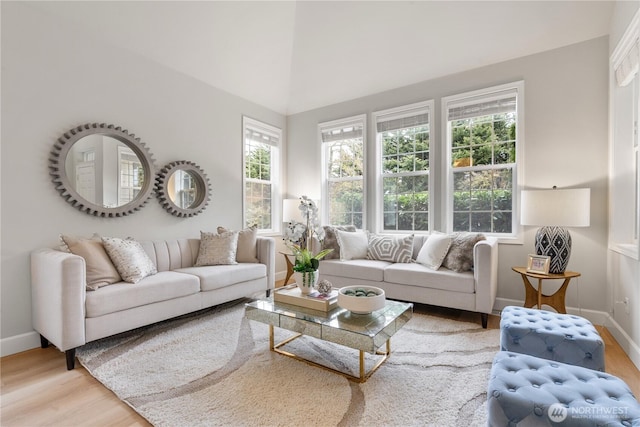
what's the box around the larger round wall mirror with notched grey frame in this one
[49,123,155,217]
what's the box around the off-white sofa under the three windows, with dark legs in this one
[319,235,498,328]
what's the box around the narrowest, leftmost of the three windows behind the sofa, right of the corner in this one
[318,115,366,228]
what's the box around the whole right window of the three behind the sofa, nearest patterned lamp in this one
[442,82,524,235]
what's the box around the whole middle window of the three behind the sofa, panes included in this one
[373,101,433,232]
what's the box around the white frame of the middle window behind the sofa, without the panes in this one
[371,99,437,234]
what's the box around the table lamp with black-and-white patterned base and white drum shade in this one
[521,186,591,274]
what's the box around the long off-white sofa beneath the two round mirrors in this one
[31,237,275,369]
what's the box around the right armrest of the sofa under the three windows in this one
[473,237,498,314]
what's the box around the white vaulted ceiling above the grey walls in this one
[31,0,614,114]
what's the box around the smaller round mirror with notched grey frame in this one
[156,160,210,217]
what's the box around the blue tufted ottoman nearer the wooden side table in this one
[500,306,604,372]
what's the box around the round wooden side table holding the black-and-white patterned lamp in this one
[511,267,580,314]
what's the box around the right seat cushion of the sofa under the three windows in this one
[384,263,475,293]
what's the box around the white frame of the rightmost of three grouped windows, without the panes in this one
[441,80,525,243]
